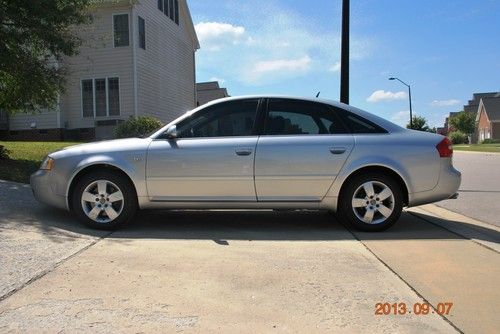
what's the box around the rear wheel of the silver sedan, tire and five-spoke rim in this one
[338,173,403,232]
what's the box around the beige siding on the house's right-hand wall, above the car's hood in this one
[134,0,196,123]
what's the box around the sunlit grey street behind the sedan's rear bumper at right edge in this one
[437,151,500,226]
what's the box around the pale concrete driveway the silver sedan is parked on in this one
[0,182,500,333]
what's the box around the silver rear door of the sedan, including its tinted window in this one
[255,99,354,202]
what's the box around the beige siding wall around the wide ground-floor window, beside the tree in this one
[60,6,134,129]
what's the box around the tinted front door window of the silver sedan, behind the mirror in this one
[177,100,258,138]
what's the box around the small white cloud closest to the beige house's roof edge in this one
[195,22,245,51]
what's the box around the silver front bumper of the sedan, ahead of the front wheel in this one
[30,170,69,210]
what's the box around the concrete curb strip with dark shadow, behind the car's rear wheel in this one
[407,204,500,253]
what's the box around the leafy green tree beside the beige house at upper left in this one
[0,0,92,113]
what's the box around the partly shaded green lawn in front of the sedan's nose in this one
[0,141,78,183]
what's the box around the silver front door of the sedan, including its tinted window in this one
[146,99,259,202]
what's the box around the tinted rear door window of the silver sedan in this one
[264,100,347,136]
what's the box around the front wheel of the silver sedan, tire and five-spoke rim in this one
[71,171,137,230]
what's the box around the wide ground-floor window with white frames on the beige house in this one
[82,78,120,118]
